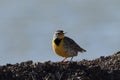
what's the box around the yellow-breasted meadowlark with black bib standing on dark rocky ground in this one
[52,30,86,62]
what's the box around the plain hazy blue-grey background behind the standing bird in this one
[0,0,120,65]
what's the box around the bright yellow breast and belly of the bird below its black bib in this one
[52,40,69,57]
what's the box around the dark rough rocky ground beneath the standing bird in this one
[0,52,120,80]
